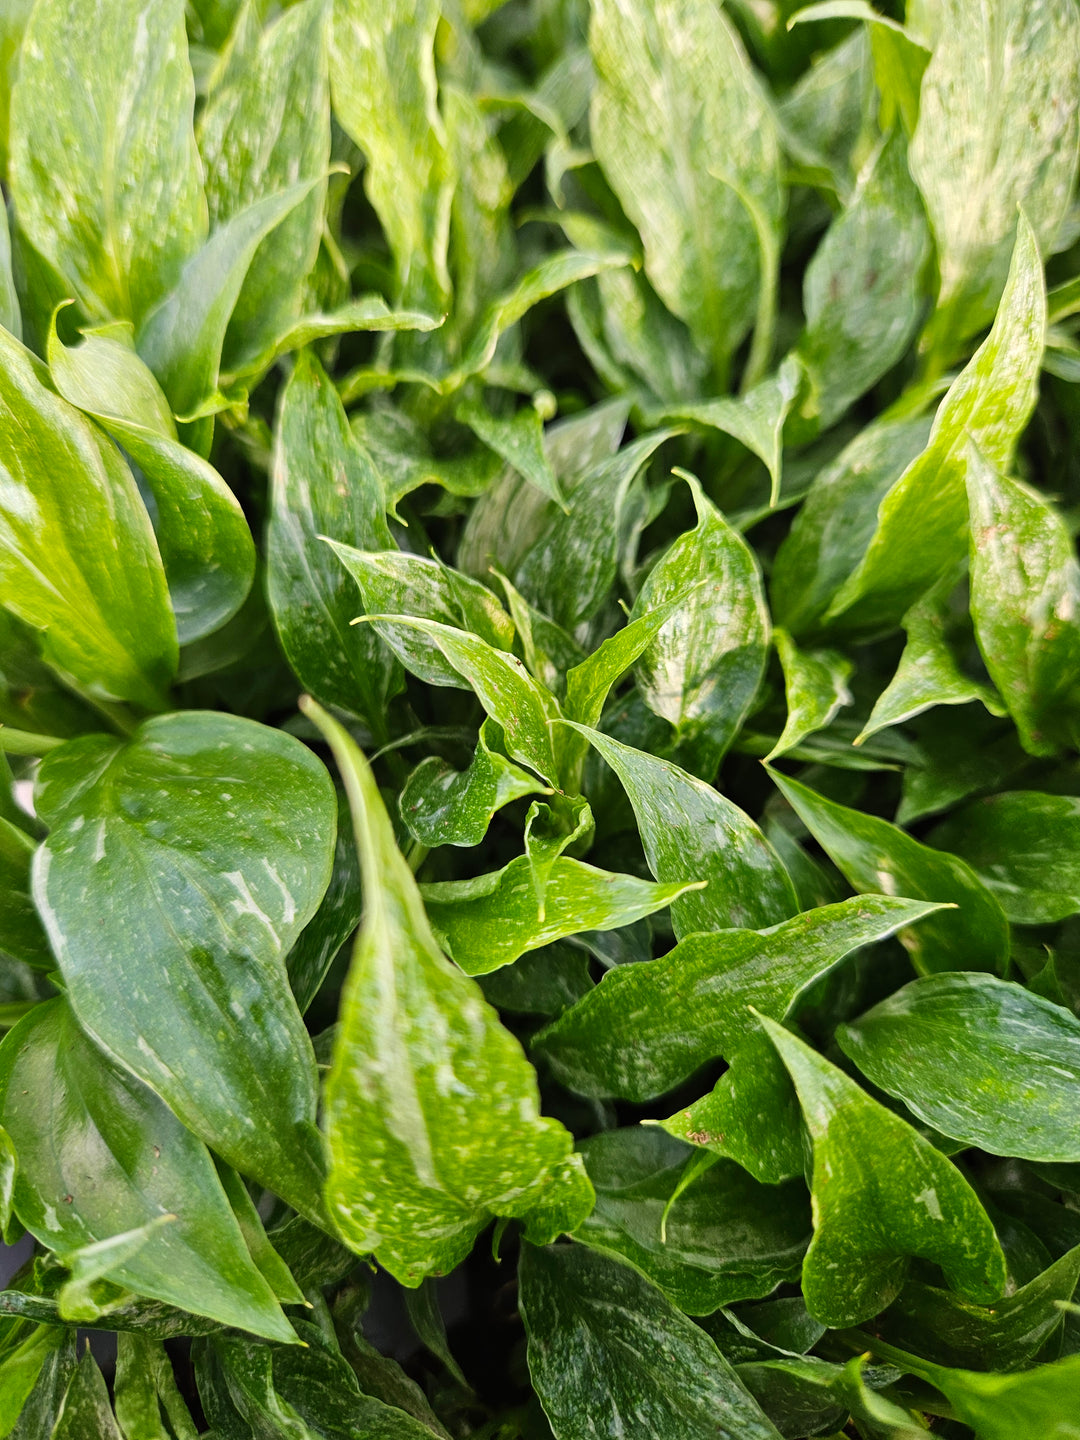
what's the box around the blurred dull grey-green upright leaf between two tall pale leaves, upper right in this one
[798,130,930,429]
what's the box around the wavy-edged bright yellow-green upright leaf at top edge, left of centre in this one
[330,0,454,314]
